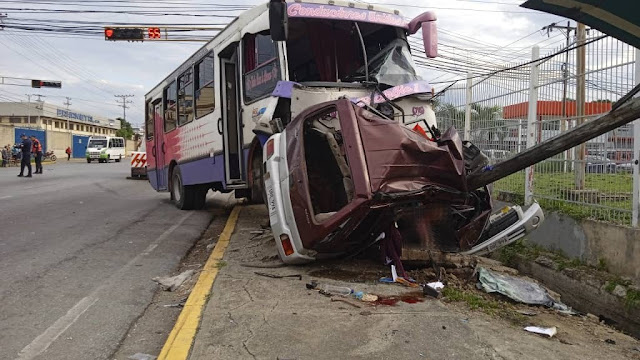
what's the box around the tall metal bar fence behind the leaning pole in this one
[435,30,640,226]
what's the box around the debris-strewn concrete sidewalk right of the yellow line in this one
[190,206,640,360]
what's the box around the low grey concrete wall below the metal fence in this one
[528,213,640,280]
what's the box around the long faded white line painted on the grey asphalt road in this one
[17,211,194,360]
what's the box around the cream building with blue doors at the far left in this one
[0,102,120,157]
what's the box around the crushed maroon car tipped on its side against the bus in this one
[264,99,544,263]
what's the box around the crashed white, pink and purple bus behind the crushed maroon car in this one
[145,0,437,210]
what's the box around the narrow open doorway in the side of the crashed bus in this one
[220,52,246,188]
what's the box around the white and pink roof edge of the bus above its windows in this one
[145,0,406,101]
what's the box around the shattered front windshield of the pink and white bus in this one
[287,18,420,88]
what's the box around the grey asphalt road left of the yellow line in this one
[0,161,212,359]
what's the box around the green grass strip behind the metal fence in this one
[494,168,633,225]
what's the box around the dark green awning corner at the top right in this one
[520,0,640,48]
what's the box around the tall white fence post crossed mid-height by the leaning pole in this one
[524,45,540,206]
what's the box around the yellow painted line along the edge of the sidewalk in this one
[158,206,241,360]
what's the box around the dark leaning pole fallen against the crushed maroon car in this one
[467,97,640,189]
